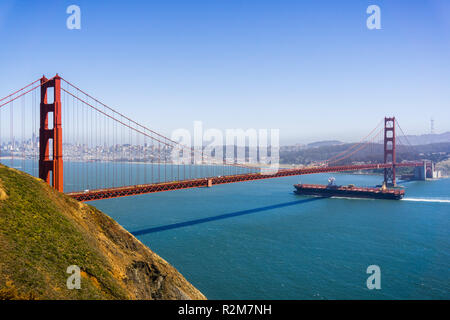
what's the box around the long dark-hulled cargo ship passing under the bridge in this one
[294,178,405,200]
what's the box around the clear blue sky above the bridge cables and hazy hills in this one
[0,0,450,144]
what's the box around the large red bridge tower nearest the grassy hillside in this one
[39,75,64,192]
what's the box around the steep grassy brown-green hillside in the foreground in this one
[0,165,204,299]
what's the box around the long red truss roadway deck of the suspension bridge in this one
[67,162,424,201]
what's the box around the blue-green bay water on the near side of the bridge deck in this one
[5,163,450,299]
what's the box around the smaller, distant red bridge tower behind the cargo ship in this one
[384,117,396,187]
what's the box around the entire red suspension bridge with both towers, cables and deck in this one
[0,74,430,201]
